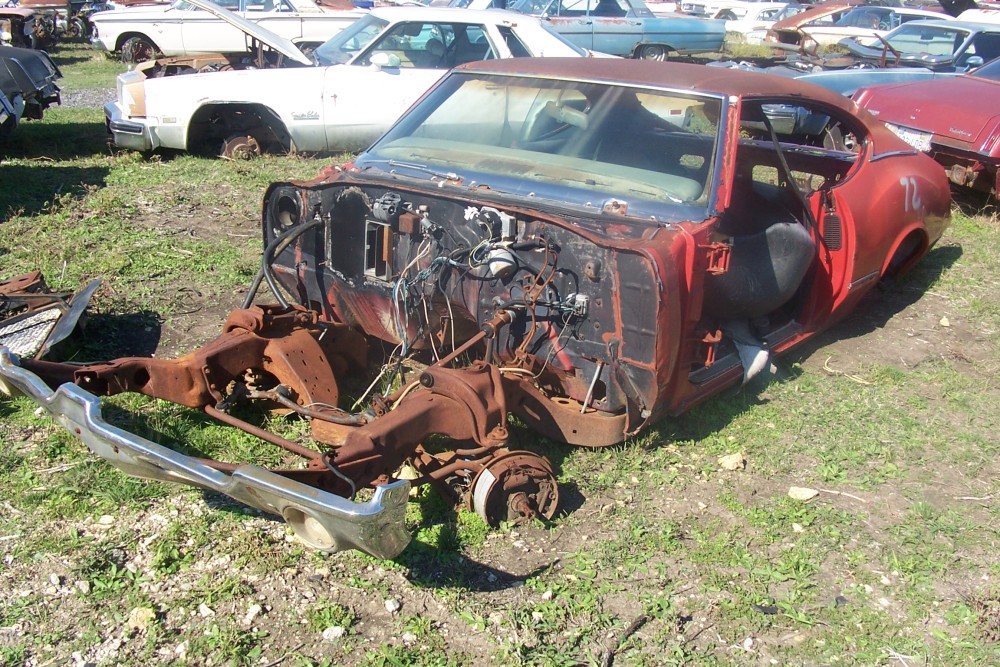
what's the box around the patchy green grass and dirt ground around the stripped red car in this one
[0,40,1000,667]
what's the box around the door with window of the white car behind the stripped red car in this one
[323,21,496,150]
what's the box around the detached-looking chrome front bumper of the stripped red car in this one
[0,347,410,558]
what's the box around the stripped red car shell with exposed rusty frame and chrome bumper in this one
[0,58,950,557]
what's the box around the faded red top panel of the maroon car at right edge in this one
[862,76,1000,146]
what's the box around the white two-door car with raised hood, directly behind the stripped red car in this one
[104,0,597,157]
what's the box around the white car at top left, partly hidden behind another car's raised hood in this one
[90,0,366,63]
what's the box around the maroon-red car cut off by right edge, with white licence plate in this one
[854,58,1000,196]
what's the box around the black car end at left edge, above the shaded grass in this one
[0,46,62,139]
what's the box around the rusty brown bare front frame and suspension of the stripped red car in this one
[15,306,556,523]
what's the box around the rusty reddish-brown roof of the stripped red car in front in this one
[455,58,868,108]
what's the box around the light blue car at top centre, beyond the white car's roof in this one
[509,0,726,60]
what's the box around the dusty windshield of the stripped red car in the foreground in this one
[355,72,722,221]
